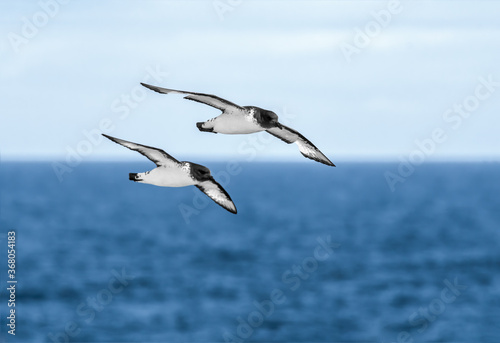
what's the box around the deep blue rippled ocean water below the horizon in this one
[0,161,500,342]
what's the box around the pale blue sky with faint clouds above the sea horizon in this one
[0,0,500,162]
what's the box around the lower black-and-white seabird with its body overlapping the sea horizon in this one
[103,134,237,213]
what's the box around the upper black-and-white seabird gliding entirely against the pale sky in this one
[141,83,335,167]
